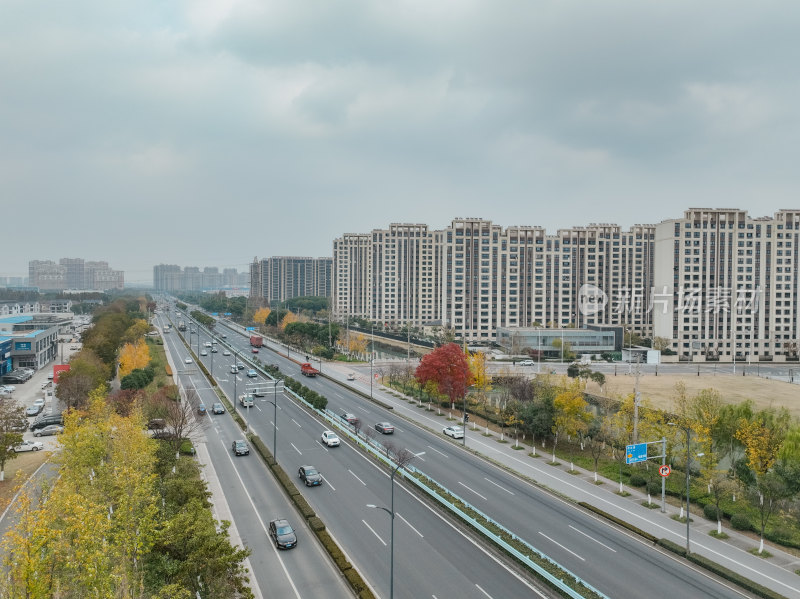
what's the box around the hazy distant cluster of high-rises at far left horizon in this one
[28,258,125,291]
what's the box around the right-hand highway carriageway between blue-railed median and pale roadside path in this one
[177,310,800,598]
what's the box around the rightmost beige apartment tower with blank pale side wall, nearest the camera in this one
[652,208,800,361]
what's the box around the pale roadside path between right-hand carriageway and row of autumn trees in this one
[318,362,800,597]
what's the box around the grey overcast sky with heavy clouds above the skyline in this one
[0,0,800,284]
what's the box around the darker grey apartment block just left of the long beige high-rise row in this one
[250,256,333,302]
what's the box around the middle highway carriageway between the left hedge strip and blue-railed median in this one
[167,312,550,599]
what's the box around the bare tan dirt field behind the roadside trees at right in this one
[587,374,800,418]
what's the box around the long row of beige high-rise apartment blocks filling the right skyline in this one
[332,209,800,361]
